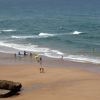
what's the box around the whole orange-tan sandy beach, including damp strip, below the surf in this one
[0,53,100,100]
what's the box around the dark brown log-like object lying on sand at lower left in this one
[0,80,22,97]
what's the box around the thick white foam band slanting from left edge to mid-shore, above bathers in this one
[0,41,63,57]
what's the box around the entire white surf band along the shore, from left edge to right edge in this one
[0,41,100,64]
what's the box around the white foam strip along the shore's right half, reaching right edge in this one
[45,51,100,64]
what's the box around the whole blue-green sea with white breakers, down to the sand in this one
[0,0,100,64]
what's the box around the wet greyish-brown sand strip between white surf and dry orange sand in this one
[0,52,100,73]
